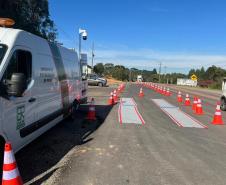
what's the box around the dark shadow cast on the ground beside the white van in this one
[16,105,112,185]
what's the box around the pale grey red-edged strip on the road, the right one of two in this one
[152,99,207,128]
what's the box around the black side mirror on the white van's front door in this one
[6,73,27,97]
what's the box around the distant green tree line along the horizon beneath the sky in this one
[94,63,226,88]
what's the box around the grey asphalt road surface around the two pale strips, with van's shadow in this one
[16,85,226,185]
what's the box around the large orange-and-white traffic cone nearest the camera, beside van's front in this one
[2,143,23,185]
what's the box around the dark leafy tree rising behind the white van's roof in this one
[0,0,57,41]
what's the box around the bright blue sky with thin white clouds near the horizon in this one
[49,0,226,73]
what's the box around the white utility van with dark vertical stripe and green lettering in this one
[0,28,86,155]
